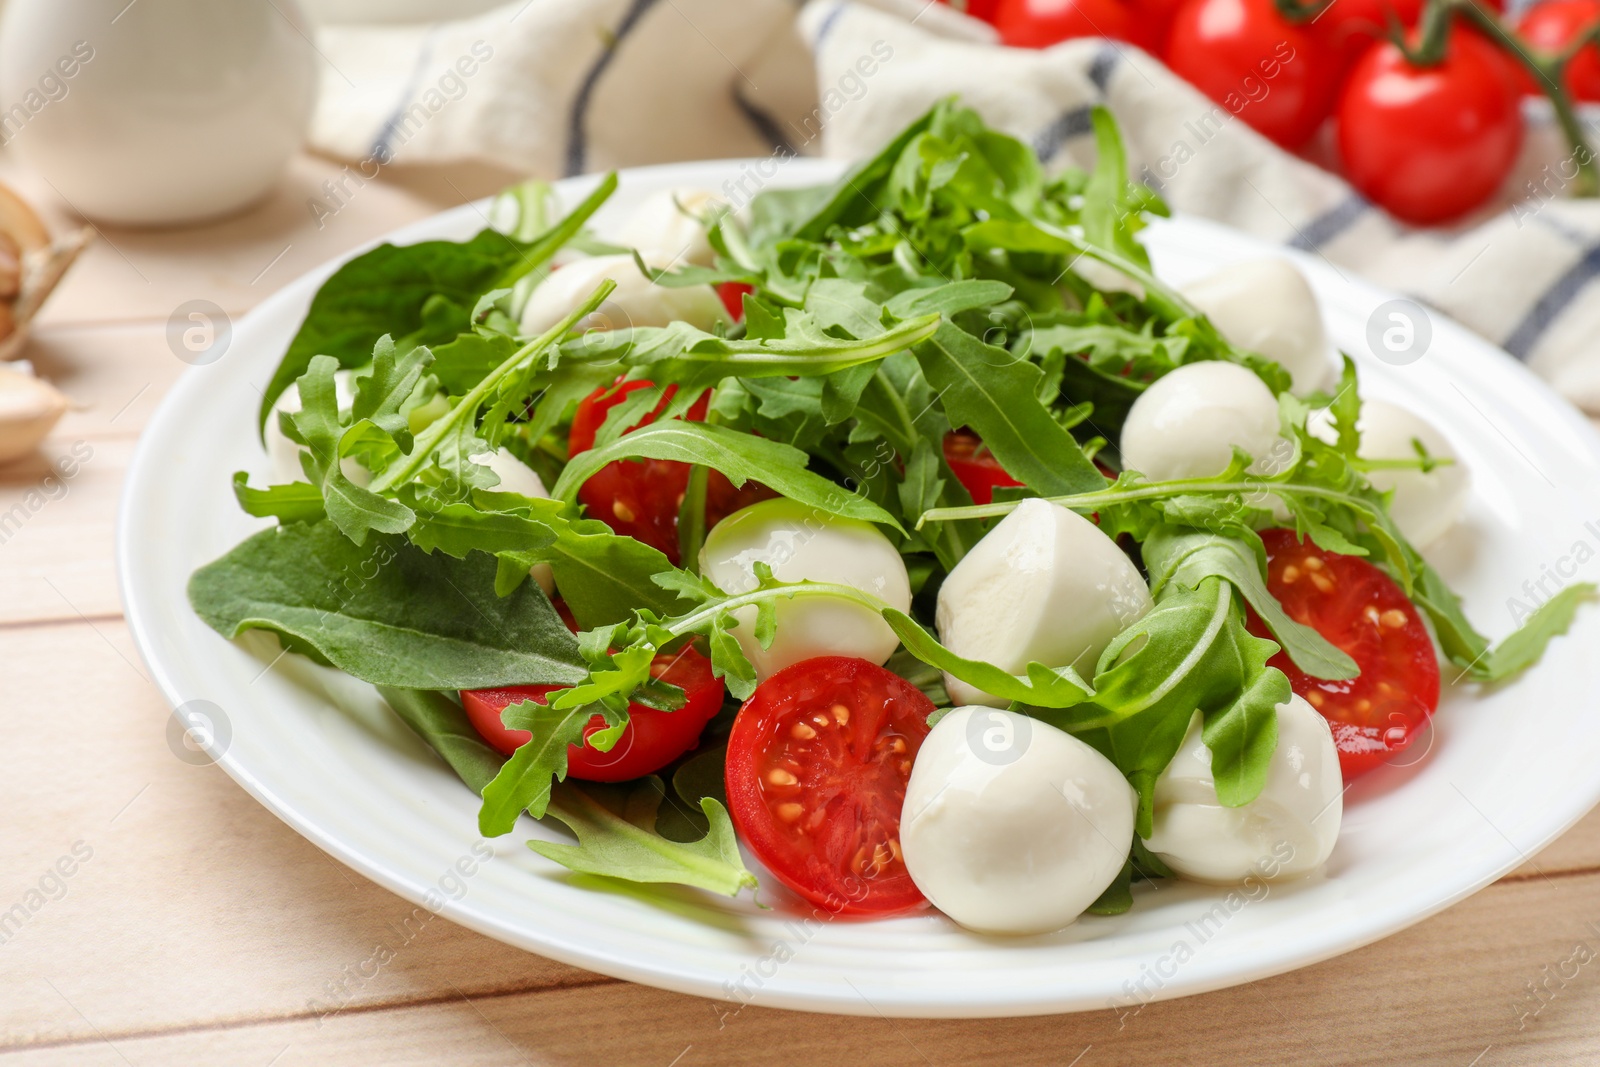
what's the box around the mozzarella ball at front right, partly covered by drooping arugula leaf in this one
[1146,696,1344,885]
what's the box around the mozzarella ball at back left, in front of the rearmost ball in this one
[522,256,728,334]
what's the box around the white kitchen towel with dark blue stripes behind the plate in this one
[312,0,1600,414]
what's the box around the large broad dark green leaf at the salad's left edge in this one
[189,522,587,689]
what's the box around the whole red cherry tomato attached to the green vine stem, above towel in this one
[1338,26,1522,224]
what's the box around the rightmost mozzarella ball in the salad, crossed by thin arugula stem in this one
[1357,400,1472,547]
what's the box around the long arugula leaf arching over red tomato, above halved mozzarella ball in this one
[550,419,899,530]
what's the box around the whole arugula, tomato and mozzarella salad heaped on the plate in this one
[189,101,1592,934]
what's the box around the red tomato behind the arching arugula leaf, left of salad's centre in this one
[566,381,771,565]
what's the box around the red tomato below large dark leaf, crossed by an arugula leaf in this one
[461,648,723,782]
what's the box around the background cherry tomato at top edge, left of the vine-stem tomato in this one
[1165,0,1339,149]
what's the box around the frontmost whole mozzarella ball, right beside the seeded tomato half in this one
[901,707,1138,934]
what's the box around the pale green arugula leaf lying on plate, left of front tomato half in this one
[528,776,755,896]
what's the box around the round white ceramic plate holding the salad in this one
[118,162,1600,1016]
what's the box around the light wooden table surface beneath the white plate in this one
[0,147,1600,1067]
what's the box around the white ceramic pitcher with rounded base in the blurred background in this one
[0,0,318,226]
